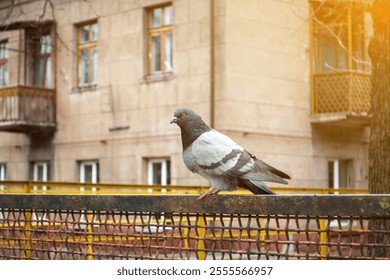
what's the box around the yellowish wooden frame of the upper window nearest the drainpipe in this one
[146,2,173,76]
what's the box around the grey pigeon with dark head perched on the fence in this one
[171,108,291,199]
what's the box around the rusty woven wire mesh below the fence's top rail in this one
[0,201,390,260]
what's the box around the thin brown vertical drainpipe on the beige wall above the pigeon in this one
[210,0,215,128]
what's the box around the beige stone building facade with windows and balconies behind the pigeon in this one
[0,0,371,188]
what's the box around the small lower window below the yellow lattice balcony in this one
[328,160,352,190]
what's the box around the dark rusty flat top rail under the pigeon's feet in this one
[0,194,390,217]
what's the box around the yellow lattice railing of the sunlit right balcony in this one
[312,71,371,123]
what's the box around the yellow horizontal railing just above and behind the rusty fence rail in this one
[0,181,368,195]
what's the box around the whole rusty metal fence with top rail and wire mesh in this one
[0,194,390,259]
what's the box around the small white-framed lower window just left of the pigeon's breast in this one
[148,159,171,186]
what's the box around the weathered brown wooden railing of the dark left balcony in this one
[0,85,56,133]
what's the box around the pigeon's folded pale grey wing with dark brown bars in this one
[192,130,289,184]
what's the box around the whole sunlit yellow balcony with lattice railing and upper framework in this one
[310,1,373,126]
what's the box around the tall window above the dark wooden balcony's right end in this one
[33,34,53,88]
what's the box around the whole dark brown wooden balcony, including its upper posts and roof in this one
[0,21,56,134]
